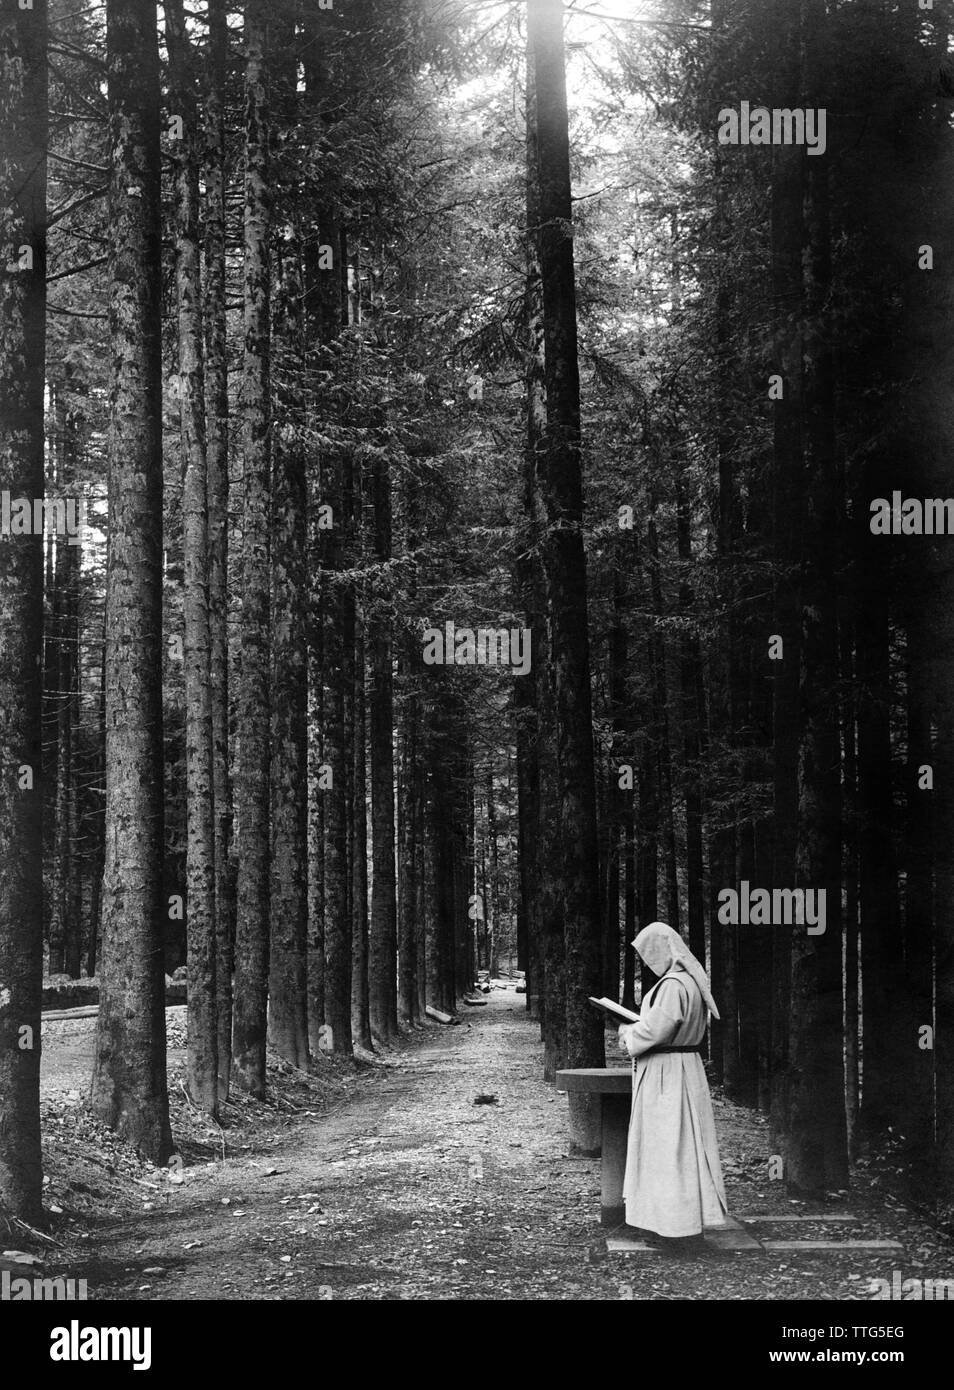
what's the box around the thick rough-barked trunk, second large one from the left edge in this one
[92,0,172,1163]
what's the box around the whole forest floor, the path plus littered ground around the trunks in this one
[7,988,954,1300]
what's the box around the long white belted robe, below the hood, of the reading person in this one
[620,967,726,1236]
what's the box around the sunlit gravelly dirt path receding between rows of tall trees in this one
[48,991,954,1300]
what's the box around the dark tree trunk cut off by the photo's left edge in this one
[0,6,47,1222]
